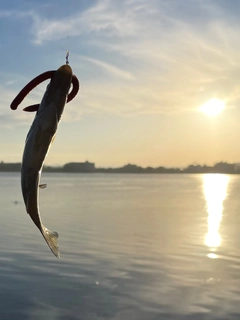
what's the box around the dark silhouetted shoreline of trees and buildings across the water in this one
[0,161,240,174]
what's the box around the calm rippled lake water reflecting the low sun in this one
[0,173,240,320]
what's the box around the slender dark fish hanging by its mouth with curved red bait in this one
[11,64,79,257]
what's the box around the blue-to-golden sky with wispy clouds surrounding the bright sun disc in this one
[0,0,240,167]
